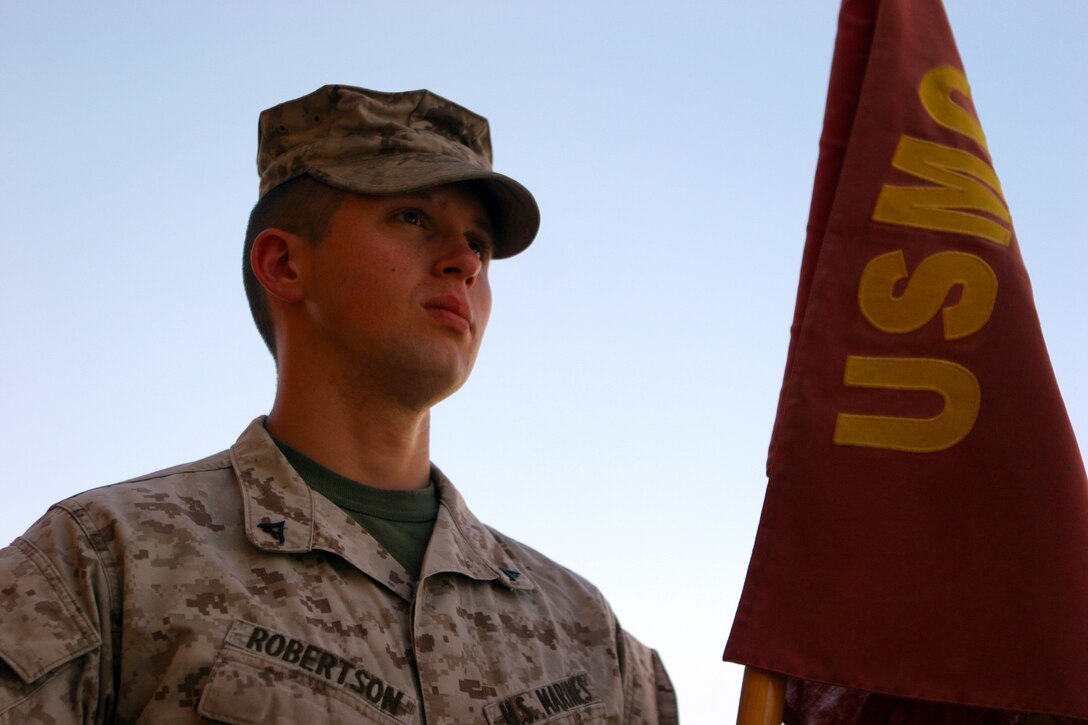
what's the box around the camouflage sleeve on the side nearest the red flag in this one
[617,629,680,725]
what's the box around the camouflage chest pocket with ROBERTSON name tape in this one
[197,622,417,725]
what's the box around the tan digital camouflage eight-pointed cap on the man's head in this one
[257,85,540,258]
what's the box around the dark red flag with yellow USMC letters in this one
[726,0,1088,722]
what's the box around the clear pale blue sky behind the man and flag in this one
[0,0,1088,724]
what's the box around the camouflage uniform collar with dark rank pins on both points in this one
[231,416,534,600]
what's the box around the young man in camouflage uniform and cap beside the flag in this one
[0,86,676,725]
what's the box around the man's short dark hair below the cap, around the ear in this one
[242,175,349,359]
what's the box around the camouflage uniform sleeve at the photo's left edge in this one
[0,507,112,725]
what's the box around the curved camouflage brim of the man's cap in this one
[307,153,541,259]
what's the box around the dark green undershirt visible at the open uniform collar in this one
[275,441,438,579]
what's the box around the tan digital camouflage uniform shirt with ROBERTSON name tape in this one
[0,418,677,725]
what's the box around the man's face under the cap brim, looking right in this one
[306,184,493,406]
